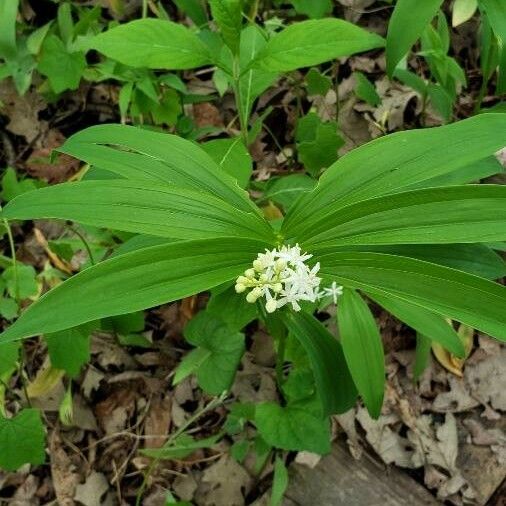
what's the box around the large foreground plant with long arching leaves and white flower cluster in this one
[0,114,506,430]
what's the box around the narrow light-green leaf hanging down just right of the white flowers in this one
[337,289,385,418]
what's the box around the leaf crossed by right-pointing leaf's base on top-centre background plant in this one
[236,25,278,129]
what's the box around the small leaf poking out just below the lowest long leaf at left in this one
[44,325,93,378]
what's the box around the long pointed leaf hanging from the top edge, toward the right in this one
[386,0,443,77]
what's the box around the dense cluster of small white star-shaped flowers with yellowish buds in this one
[235,244,321,313]
